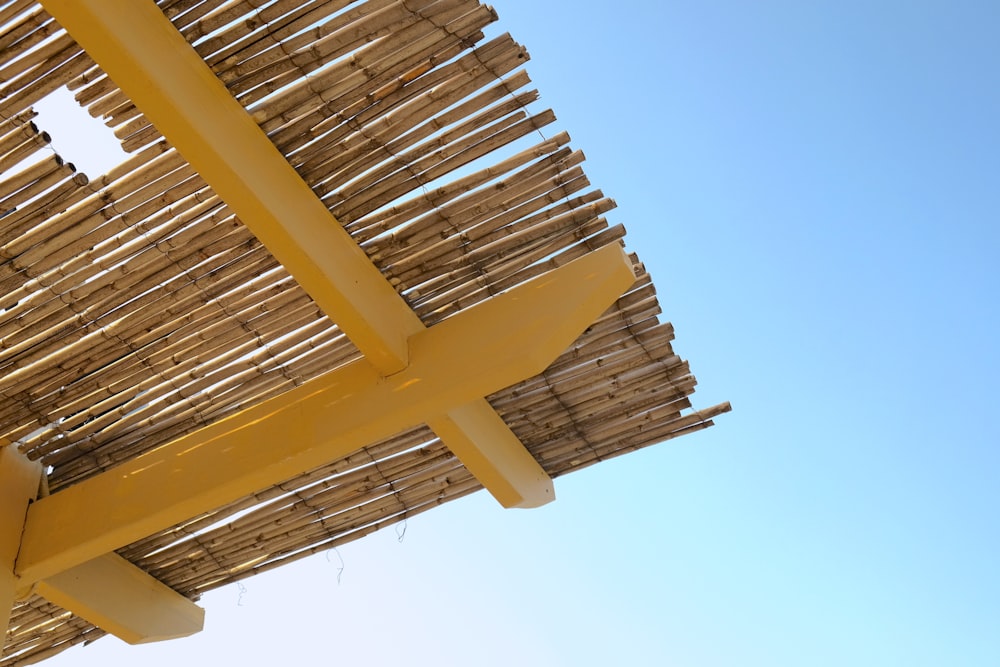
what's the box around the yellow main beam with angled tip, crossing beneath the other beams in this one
[15,246,635,581]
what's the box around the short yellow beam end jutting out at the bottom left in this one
[36,553,205,644]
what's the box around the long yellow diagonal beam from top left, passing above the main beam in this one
[42,0,555,507]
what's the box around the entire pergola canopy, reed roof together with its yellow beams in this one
[0,0,729,667]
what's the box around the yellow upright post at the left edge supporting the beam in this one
[0,440,42,648]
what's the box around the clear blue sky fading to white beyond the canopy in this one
[39,0,1000,667]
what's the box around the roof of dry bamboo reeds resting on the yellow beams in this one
[0,0,729,667]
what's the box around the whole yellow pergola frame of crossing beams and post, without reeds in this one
[0,0,635,643]
